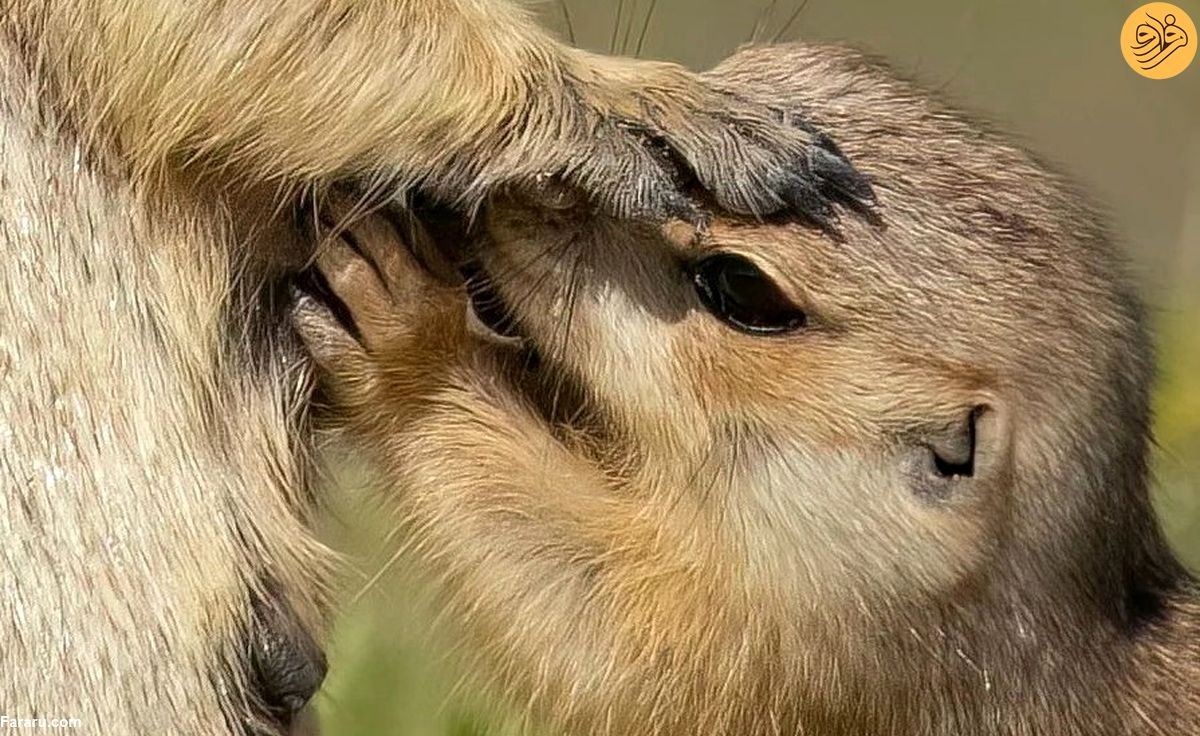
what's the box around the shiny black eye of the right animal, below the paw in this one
[689,253,806,335]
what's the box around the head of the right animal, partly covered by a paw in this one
[458,47,1151,624]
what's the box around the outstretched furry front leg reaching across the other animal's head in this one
[9,0,871,223]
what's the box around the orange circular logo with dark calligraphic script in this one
[1121,2,1196,79]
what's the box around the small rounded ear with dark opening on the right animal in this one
[904,403,1008,501]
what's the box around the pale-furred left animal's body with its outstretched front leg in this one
[0,0,862,734]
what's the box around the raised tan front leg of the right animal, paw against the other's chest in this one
[288,204,758,736]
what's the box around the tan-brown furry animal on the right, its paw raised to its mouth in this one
[298,47,1200,736]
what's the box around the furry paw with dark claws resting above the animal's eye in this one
[520,55,875,229]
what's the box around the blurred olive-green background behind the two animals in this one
[317,0,1200,736]
